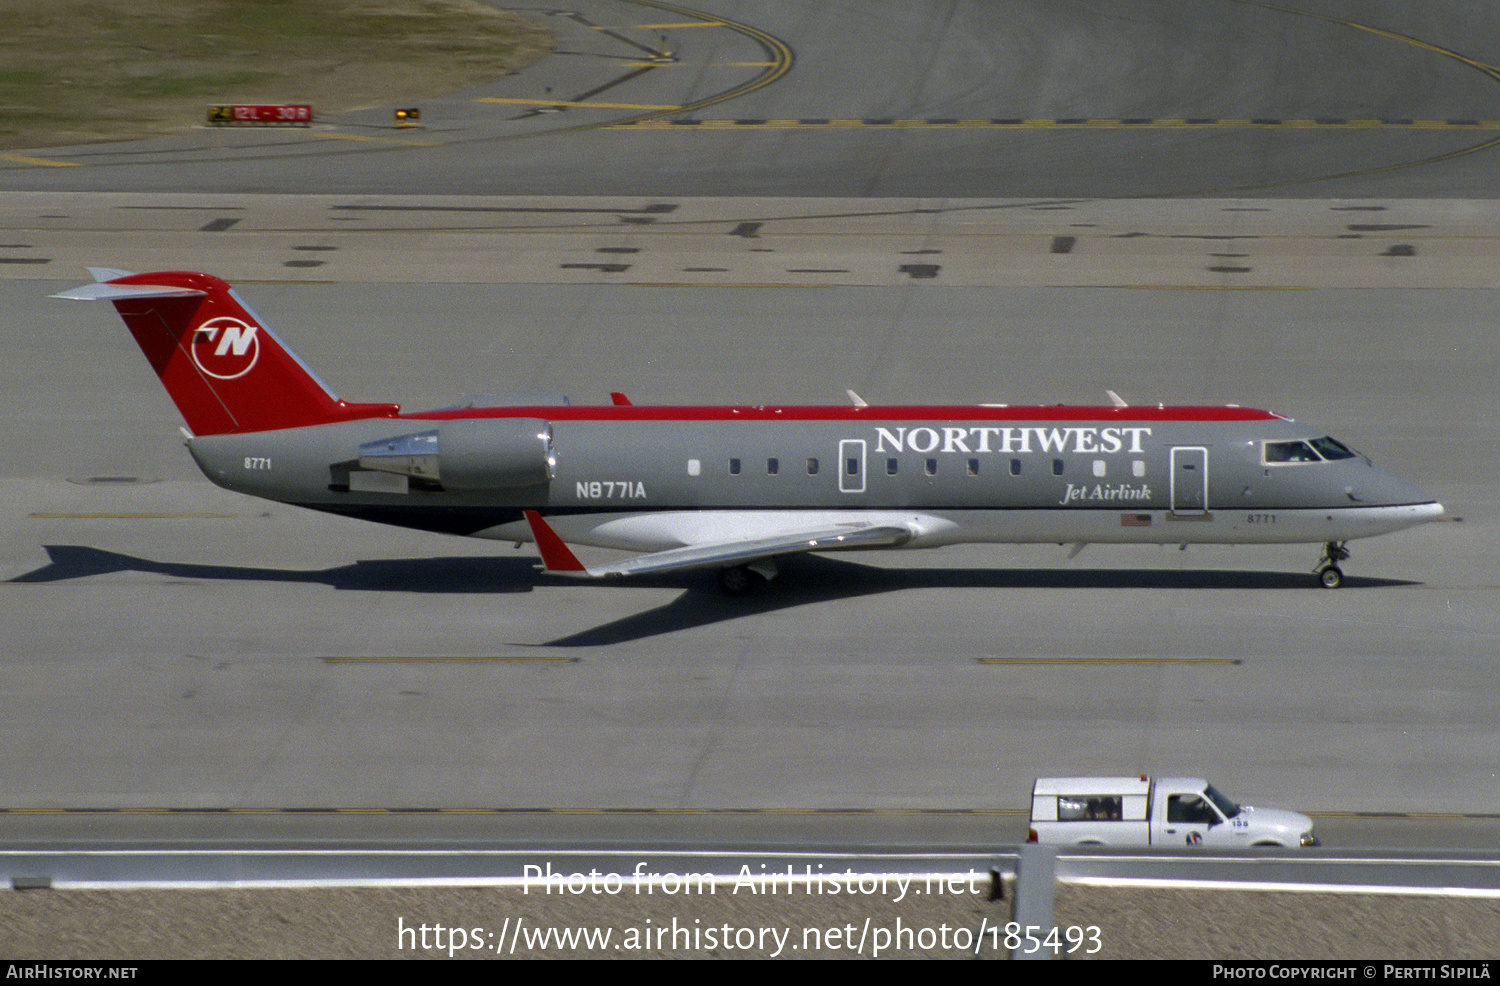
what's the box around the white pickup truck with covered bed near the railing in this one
[1028,774,1317,846]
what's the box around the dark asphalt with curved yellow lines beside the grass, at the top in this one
[0,0,1500,198]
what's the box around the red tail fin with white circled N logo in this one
[53,270,401,435]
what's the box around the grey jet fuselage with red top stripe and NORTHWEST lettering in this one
[189,407,1442,549]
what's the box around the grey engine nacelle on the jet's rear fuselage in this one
[360,417,557,491]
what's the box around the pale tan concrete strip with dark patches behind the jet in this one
[0,192,1500,290]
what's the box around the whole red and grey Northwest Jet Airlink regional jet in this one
[56,269,1443,593]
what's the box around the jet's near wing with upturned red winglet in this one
[527,510,912,578]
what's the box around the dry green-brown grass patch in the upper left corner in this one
[0,0,554,149]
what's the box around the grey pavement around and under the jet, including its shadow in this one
[0,241,1500,813]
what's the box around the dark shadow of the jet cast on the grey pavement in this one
[11,545,1415,647]
